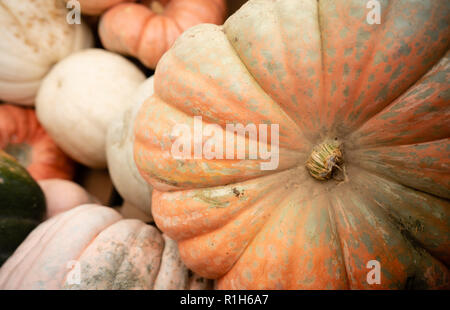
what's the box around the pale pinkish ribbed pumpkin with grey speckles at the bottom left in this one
[0,204,201,290]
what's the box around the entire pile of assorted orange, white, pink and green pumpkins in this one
[0,0,450,289]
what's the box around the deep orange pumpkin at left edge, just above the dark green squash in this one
[0,104,74,180]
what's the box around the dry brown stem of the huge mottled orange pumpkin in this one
[306,140,344,181]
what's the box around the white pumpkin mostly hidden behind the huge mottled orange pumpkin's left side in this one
[106,77,153,217]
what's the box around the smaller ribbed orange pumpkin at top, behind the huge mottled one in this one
[99,0,226,68]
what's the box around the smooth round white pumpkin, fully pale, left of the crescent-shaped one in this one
[36,49,145,168]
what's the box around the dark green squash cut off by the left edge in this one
[0,150,46,266]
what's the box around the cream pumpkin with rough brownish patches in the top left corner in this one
[0,0,93,105]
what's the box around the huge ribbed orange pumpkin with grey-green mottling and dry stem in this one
[134,0,450,289]
